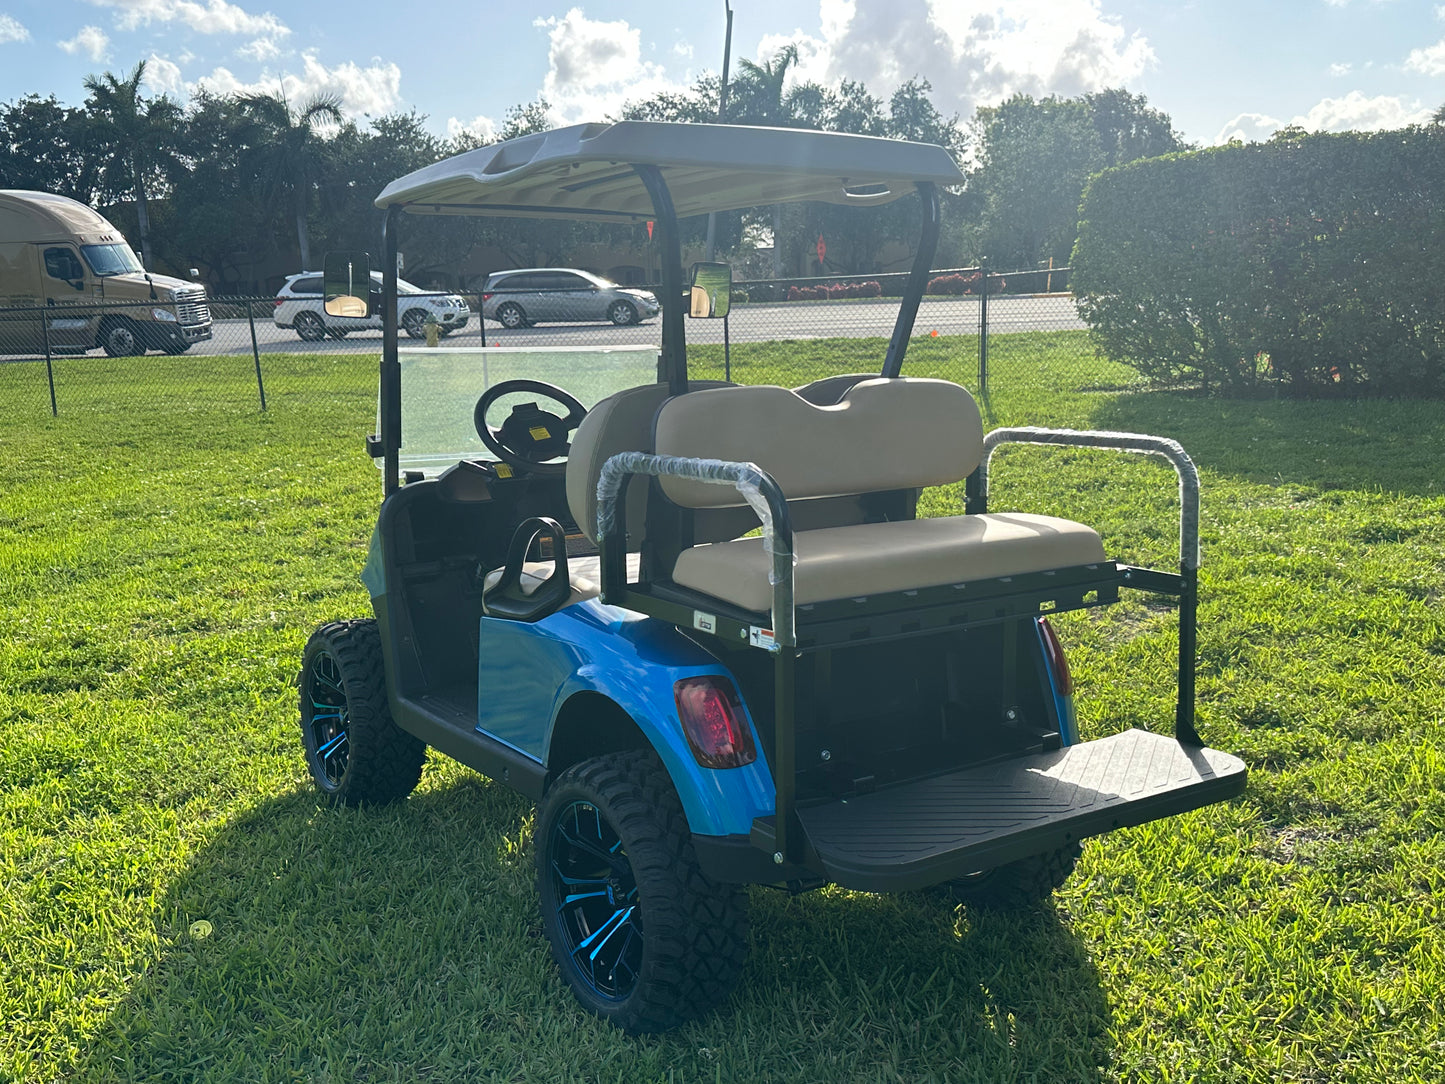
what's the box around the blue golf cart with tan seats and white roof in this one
[301,121,1244,1032]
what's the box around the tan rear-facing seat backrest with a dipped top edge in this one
[653,377,984,515]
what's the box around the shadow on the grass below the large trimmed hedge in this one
[1088,392,1445,496]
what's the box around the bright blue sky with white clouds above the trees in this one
[0,0,1445,146]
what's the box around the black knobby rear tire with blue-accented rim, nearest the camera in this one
[536,750,747,1035]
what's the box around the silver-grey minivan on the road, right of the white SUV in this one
[481,267,659,328]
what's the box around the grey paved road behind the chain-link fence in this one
[191,296,1085,354]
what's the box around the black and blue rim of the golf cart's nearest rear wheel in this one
[546,801,643,1002]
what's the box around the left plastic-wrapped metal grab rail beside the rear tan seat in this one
[597,452,796,652]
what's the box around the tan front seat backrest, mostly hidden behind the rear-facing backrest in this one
[566,380,730,552]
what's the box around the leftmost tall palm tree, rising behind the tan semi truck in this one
[85,61,182,270]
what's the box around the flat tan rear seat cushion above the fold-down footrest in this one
[672,513,1104,613]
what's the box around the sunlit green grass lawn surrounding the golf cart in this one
[0,332,1445,1084]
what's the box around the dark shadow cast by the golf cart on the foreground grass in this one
[74,779,1108,1081]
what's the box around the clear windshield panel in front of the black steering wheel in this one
[376,345,657,478]
